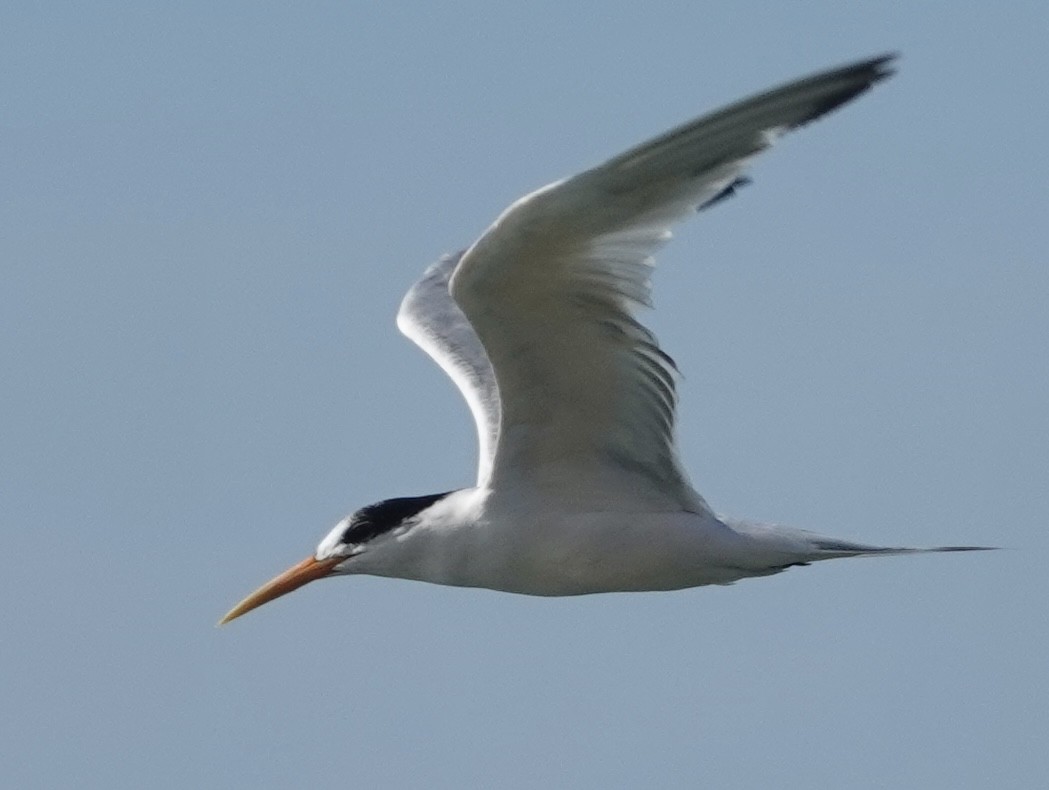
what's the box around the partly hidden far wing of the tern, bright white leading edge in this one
[397,253,499,486]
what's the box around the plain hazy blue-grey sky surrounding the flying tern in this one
[0,0,1049,789]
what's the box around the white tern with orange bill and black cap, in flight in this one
[219,55,986,624]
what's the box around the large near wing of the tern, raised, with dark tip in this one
[446,57,892,510]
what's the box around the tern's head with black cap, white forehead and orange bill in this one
[218,492,449,625]
